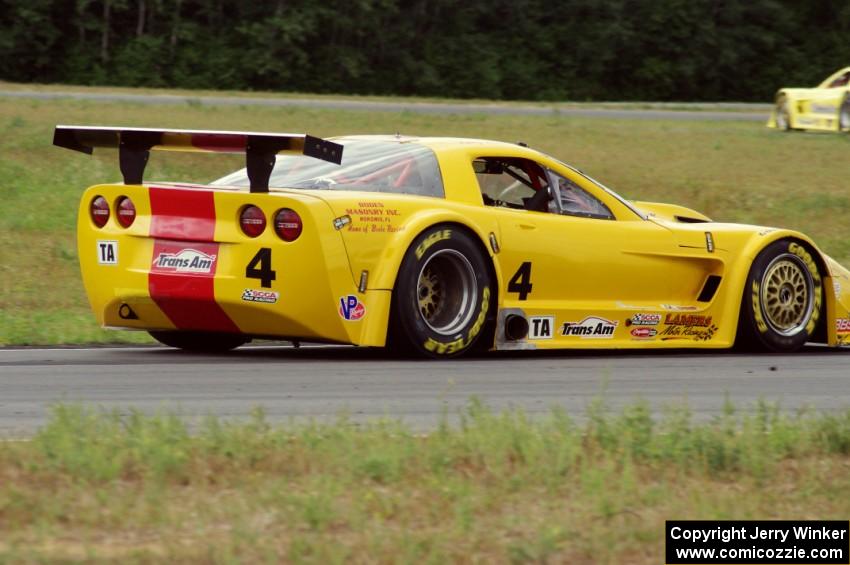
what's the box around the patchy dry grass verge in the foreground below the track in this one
[0,400,850,563]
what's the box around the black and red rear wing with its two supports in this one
[53,126,343,192]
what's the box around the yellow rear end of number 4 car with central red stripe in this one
[78,185,390,345]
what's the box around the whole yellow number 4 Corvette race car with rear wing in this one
[54,126,850,357]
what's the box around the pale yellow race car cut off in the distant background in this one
[767,67,850,131]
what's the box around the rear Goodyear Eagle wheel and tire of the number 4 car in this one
[388,225,496,358]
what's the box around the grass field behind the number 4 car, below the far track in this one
[0,89,850,344]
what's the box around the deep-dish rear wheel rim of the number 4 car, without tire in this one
[416,249,478,335]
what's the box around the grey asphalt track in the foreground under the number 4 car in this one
[0,345,850,437]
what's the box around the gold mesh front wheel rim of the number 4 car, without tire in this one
[760,253,814,336]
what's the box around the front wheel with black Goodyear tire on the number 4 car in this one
[737,239,824,352]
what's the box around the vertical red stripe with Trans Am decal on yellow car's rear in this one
[148,188,239,333]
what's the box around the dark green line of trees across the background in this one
[0,0,850,101]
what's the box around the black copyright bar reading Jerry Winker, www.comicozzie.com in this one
[665,520,850,565]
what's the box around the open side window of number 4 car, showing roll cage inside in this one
[472,157,557,212]
